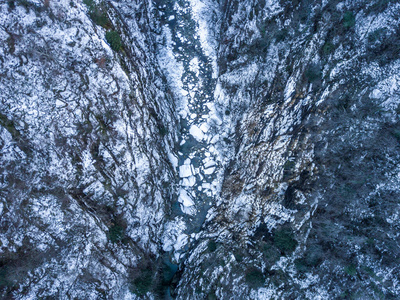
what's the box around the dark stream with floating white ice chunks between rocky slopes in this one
[159,0,222,296]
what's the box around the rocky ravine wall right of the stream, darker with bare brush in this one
[172,1,399,299]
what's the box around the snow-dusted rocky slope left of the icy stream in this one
[0,1,177,299]
